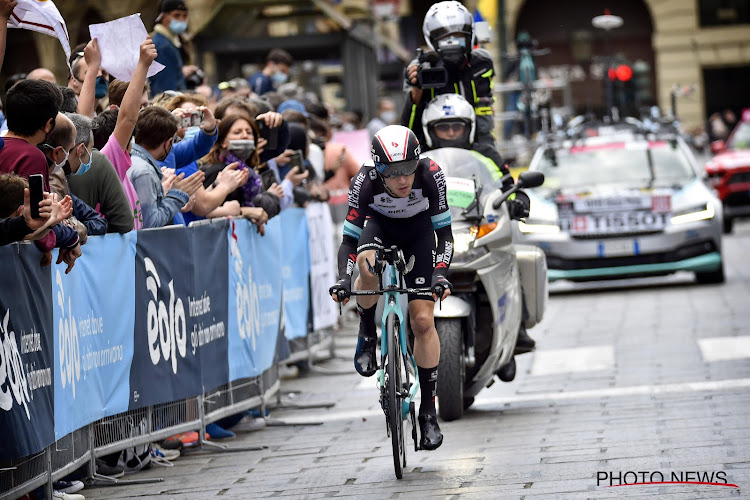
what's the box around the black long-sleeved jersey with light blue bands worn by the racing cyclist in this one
[338,158,453,290]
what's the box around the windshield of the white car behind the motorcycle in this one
[534,141,695,195]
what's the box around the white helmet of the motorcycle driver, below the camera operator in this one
[422,94,476,149]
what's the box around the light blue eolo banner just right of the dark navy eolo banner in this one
[226,217,286,380]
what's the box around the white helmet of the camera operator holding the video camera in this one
[422,0,474,60]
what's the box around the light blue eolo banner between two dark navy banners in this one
[52,232,136,439]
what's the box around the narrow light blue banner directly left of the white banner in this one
[280,208,310,340]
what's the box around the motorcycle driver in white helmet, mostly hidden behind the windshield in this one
[422,94,536,354]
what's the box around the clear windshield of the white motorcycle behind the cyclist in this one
[422,148,502,219]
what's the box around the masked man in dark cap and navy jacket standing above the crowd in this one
[151,0,197,94]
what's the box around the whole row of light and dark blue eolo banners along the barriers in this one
[0,209,318,460]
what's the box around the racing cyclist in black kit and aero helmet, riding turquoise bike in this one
[329,125,453,450]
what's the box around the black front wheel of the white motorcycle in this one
[435,319,466,421]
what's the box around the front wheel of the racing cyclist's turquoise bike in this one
[385,313,406,479]
